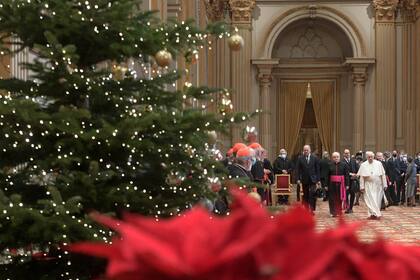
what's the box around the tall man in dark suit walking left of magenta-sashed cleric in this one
[296,145,321,214]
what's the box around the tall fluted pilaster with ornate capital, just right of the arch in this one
[373,0,398,151]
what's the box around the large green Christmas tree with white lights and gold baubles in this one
[0,0,251,279]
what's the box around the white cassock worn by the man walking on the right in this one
[357,160,387,217]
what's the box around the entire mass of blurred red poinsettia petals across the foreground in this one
[71,190,420,280]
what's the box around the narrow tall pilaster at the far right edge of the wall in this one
[401,0,417,154]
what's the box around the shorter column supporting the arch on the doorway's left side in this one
[252,60,278,154]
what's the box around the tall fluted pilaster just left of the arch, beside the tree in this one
[229,0,256,142]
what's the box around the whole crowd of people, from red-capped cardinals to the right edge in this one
[223,135,420,219]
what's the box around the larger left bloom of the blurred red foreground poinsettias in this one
[71,191,274,280]
